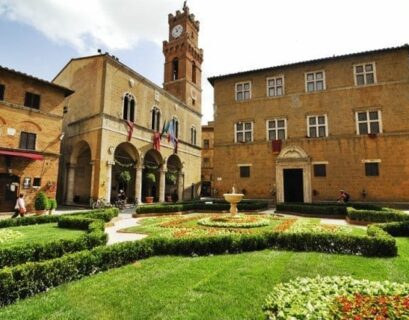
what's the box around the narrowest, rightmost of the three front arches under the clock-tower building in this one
[165,154,183,202]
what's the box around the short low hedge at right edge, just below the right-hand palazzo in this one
[348,208,409,222]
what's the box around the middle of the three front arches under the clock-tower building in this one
[142,149,163,201]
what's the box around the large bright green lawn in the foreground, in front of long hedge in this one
[0,238,409,320]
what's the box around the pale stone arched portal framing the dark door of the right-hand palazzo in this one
[276,146,312,202]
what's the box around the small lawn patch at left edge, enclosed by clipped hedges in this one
[0,223,85,249]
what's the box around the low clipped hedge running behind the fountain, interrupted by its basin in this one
[135,200,268,215]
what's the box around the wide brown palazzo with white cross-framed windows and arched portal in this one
[209,45,409,202]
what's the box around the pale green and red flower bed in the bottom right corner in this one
[263,276,409,320]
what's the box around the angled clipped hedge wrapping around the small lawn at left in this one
[0,209,118,268]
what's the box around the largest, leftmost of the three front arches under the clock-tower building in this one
[110,142,139,203]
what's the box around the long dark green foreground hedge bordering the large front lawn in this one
[0,228,397,305]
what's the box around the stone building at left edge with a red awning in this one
[0,66,73,212]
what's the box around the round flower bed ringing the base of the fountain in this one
[197,215,270,228]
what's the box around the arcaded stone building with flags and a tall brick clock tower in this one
[53,6,203,203]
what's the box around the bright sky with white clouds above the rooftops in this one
[0,0,409,123]
